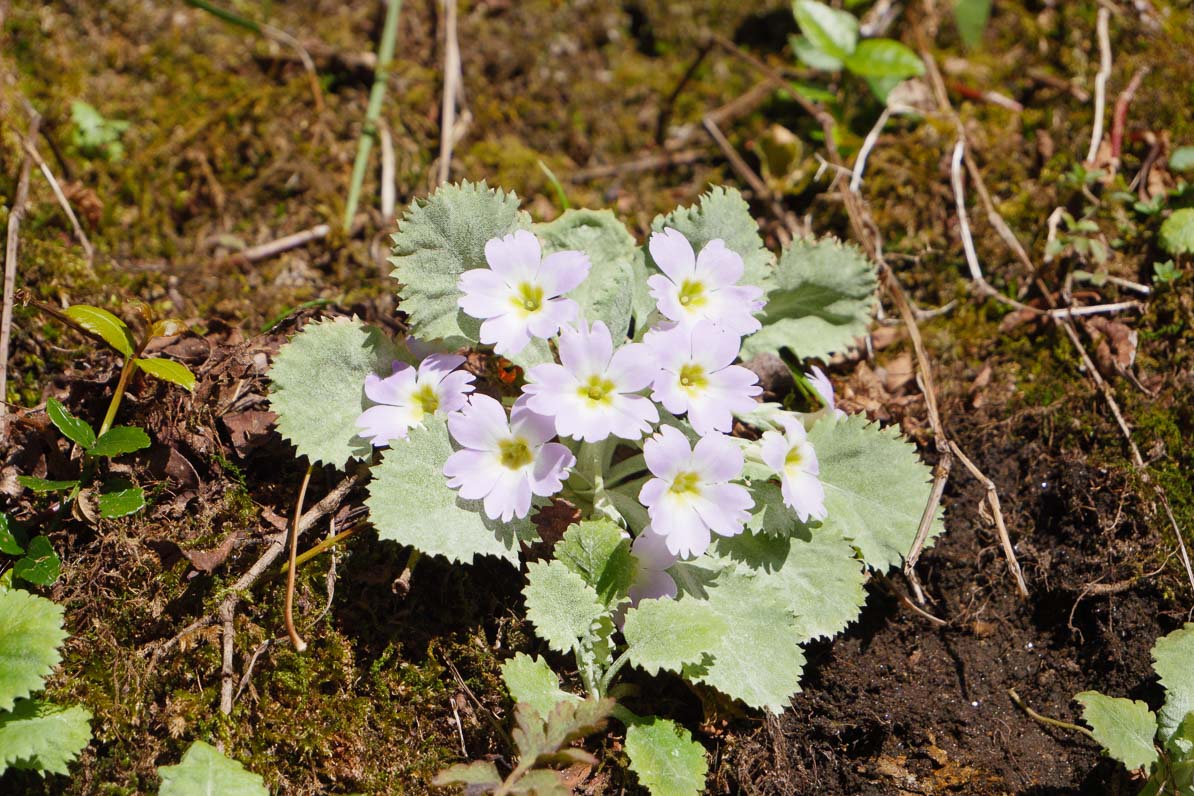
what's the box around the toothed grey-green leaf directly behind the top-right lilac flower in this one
[651,186,775,292]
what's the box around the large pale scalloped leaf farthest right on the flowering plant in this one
[808,414,943,572]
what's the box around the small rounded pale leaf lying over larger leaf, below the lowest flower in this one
[622,599,727,674]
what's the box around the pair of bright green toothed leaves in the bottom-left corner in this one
[0,590,91,775]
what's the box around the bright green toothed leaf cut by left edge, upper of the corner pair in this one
[0,590,67,710]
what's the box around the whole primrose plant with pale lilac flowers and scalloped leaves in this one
[271,183,941,794]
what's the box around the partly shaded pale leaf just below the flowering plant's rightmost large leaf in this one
[718,527,867,642]
